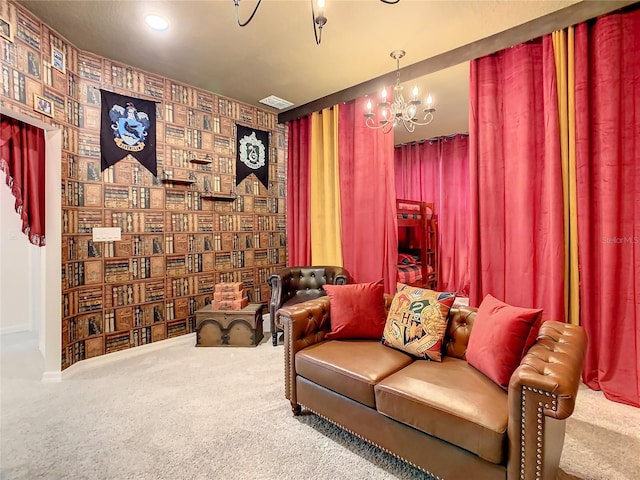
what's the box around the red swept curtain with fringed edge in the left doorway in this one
[0,115,46,247]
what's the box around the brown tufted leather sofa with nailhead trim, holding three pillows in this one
[279,297,586,480]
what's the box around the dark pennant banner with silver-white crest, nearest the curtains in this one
[236,124,269,188]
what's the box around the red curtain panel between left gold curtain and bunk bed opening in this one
[338,99,398,293]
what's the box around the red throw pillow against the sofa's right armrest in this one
[467,295,542,390]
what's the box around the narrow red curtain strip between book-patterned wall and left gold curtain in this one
[287,117,311,265]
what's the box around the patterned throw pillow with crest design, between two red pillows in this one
[382,283,456,362]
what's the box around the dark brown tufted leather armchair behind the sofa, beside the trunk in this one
[268,266,349,346]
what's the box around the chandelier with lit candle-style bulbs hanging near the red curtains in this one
[364,50,436,133]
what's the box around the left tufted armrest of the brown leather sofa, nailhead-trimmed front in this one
[278,296,331,415]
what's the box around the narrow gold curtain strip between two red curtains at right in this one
[552,27,580,325]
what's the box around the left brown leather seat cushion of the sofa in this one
[295,340,413,408]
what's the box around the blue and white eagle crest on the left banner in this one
[109,102,151,152]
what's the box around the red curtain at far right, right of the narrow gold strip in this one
[575,9,640,406]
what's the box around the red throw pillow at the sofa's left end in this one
[322,280,387,340]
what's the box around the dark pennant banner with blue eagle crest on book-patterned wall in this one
[100,90,158,176]
